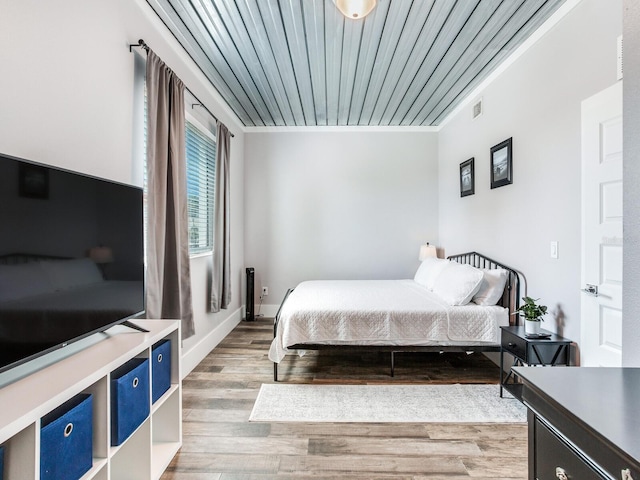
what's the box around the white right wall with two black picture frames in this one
[439,0,622,356]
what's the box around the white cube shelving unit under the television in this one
[0,320,182,480]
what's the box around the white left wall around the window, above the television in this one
[0,0,244,376]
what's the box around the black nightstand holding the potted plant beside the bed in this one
[500,327,571,401]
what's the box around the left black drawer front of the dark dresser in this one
[534,419,607,480]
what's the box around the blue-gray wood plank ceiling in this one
[147,0,565,127]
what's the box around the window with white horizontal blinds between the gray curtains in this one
[186,121,216,254]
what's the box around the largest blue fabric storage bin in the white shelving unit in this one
[40,394,93,480]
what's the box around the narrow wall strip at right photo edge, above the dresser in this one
[622,0,640,367]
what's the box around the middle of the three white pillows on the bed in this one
[433,262,483,305]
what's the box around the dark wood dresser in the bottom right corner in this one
[514,367,640,480]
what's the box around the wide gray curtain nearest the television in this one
[146,50,195,338]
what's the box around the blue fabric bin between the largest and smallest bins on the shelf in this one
[111,358,150,446]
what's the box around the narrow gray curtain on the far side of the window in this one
[211,122,231,312]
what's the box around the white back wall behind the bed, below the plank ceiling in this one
[245,131,438,305]
